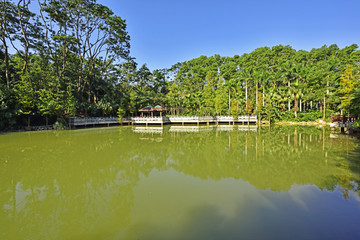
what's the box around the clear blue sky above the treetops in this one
[98,0,360,70]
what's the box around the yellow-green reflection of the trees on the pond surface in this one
[0,126,360,239]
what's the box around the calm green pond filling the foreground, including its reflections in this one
[0,126,360,240]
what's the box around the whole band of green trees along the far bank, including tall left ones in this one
[0,0,360,130]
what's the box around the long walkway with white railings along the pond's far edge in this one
[69,115,258,127]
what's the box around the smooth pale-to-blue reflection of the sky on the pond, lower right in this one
[120,171,360,239]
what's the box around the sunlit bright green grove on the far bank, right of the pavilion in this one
[169,44,360,119]
